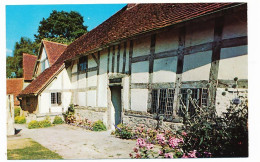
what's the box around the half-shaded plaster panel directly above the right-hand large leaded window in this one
[182,51,212,81]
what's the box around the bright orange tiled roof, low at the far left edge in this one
[6,78,24,105]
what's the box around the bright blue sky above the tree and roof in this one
[6,4,126,56]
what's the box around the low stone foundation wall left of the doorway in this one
[75,106,108,126]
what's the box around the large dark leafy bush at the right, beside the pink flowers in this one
[179,77,248,157]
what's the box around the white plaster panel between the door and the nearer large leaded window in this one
[131,89,148,112]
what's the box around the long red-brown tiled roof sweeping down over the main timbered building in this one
[21,3,241,94]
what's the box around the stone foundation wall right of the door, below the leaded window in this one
[123,114,183,130]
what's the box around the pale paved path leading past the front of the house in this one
[8,124,136,159]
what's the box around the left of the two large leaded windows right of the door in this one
[151,89,174,119]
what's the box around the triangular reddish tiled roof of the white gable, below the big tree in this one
[42,40,67,66]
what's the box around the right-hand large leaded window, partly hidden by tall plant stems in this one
[179,88,208,116]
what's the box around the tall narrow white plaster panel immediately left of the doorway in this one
[98,73,107,107]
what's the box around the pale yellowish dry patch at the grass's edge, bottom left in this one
[7,138,32,150]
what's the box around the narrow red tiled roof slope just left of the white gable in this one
[23,53,37,80]
